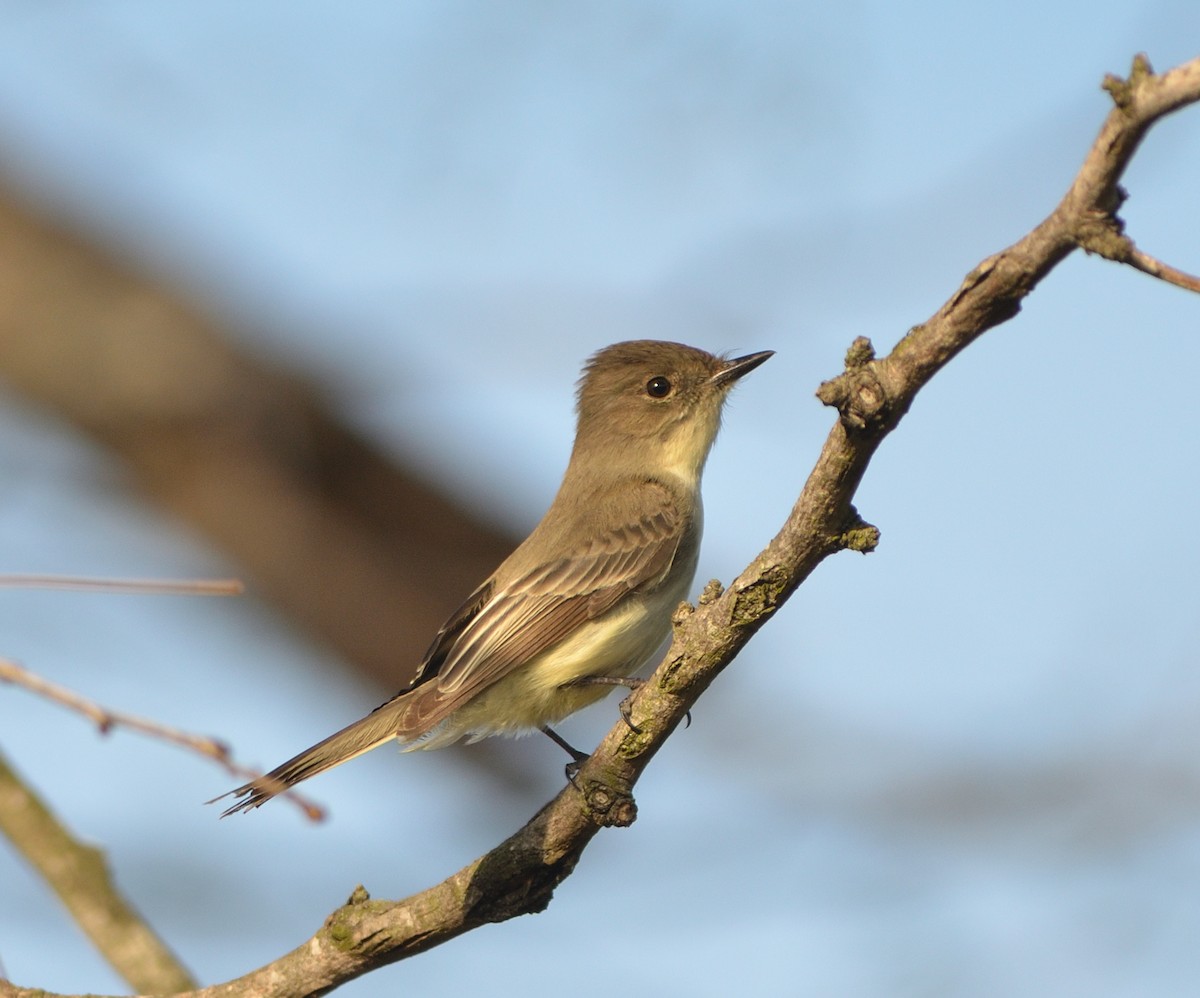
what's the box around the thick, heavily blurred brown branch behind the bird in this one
[0,179,512,695]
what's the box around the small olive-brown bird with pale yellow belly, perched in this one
[218,339,773,817]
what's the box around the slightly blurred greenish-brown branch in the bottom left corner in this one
[0,757,196,994]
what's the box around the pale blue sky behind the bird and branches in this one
[0,0,1200,996]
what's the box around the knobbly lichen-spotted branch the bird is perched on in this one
[4,56,1200,998]
